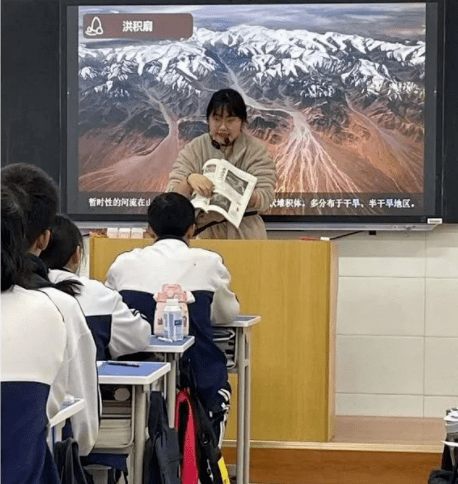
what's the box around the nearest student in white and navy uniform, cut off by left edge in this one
[1,187,68,484]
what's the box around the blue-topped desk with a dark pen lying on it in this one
[94,361,170,484]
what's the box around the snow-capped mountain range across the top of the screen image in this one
[79,25,425,103]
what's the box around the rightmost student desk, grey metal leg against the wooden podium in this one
[222,315,261,484]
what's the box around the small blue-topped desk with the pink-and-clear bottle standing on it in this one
[146,336,195,428]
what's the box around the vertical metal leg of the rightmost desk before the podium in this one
[237,328,247,484]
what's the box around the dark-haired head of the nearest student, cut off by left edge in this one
[1,185,31,292]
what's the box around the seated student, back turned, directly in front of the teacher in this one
[106,192,240,441]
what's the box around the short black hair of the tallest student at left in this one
[2,163,59,247]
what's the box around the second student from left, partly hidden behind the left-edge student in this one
[1,163,100,456]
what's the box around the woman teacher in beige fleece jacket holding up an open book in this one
[167,89,277,239]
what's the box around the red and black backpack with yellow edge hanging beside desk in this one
[175,389,230,484]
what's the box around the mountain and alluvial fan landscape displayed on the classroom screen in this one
[74,5,425,213]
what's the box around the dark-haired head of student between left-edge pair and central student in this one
[40,214,83,272]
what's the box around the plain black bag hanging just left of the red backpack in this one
[143,391,181,484]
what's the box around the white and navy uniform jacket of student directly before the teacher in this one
[106,238,240,409]
